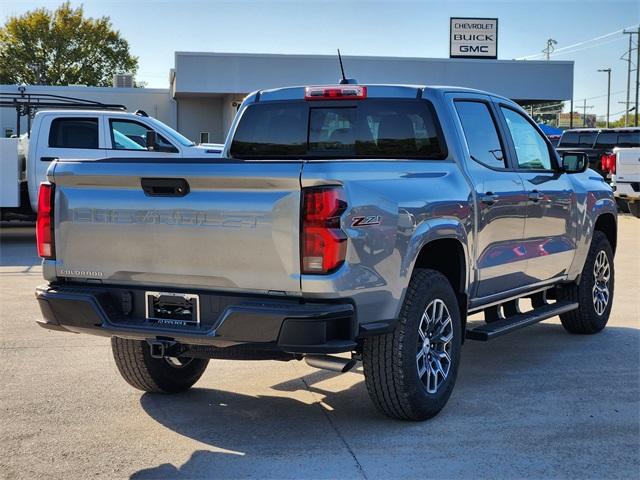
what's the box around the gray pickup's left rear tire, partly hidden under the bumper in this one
[111,337,209,393]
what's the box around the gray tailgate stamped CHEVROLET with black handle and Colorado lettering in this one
[53,160,302,294]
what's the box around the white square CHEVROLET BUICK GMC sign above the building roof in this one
[449,18,498,58]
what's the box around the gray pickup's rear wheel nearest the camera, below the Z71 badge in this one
[362,269,462,420]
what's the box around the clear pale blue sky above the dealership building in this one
[0,0,640,118]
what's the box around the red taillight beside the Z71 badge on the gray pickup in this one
[301,187,347,274]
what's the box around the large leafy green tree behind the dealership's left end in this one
[0,2,138,86]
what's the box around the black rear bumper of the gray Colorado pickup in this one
[36,285,357,353]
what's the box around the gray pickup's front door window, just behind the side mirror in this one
[500,107,552,170]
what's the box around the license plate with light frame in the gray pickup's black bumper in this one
[145,292,200,327]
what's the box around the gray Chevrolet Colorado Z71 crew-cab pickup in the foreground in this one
[36,84,617,420]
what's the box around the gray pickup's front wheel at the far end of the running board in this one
[557,230,614,334]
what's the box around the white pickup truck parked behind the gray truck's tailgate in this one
[0,110,223,220]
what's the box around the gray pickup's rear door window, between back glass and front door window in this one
[455,100,505,168]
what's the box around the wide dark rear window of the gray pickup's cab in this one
[230,99,447,160]
